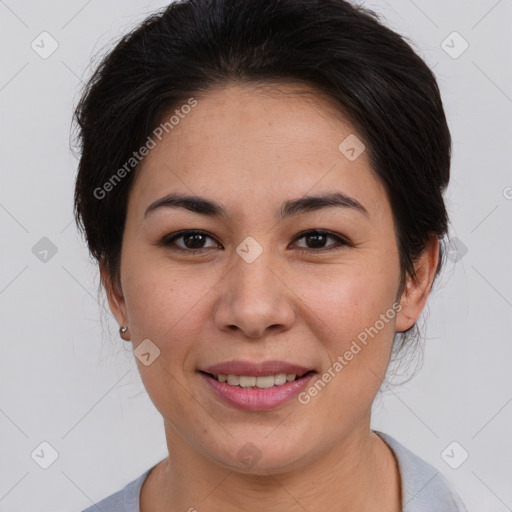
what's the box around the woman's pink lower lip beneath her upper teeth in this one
[200,372,315,411]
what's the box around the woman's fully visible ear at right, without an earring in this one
[395,235,439,332]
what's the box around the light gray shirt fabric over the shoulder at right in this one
[374,431,467,512]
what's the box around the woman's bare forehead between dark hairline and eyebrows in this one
[130,84,386,221]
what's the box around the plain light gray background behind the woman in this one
[0,0,512,512]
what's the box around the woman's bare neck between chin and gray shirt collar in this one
[140,424,401,512]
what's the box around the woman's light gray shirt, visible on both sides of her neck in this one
[82,431,467,512]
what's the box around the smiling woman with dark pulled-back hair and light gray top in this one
[75,0,465,512]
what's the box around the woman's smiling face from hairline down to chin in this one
[104,84,432,474]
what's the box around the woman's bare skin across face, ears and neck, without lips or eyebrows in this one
[101,83,439,512]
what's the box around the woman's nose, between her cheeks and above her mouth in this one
[215,245,296,339]
